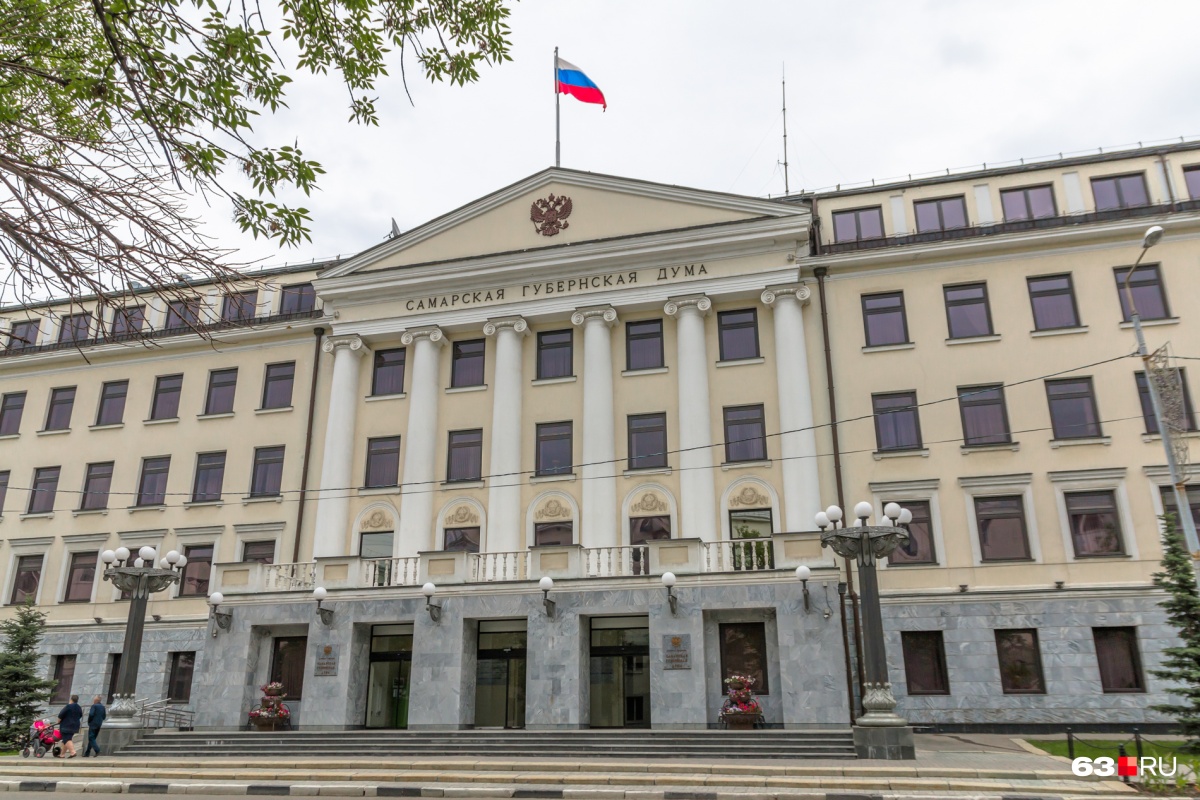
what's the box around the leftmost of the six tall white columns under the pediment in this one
[314,335,368,558]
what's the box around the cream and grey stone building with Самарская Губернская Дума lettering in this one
[0,144,1200,729]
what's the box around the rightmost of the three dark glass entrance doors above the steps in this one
[590,616,650,728]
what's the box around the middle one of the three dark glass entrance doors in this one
[475,619,528,728]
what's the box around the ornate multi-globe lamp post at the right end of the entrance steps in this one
[816,503,916,759]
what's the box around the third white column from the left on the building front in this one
[481,317,529,553]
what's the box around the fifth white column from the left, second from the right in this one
[664,295,720,542]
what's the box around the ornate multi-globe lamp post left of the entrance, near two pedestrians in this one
[100,547,187,728]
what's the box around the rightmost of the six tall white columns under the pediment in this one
[762,284,823,531]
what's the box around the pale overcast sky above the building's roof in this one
[193,0,1200,266]
